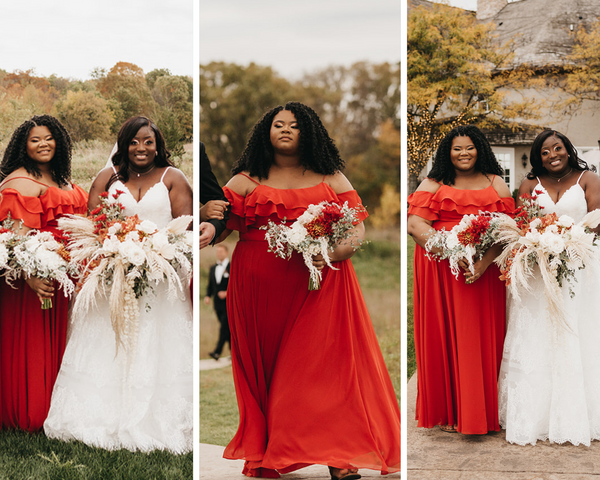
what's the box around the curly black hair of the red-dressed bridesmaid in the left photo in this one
[0,115,73,187]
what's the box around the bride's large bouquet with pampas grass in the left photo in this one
[59,191,192,351]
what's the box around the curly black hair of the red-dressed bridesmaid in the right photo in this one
[427,125,504,185]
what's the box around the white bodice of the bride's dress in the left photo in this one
[108,175,173,228]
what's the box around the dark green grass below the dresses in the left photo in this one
[0,430,193,480]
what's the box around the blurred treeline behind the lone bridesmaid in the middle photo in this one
[200,62,400,226]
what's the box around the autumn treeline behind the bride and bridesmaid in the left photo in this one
[0,62,193,156]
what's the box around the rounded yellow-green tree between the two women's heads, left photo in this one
[53,90,114,142]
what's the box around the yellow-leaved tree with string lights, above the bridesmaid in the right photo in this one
[407,4,540,191]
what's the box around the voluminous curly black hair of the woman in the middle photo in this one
[231,102,344,179]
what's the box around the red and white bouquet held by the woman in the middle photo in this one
[261,202,364,290]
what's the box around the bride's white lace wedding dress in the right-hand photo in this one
[498,172,600,446]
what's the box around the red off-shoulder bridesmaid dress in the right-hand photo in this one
[408,181,515,434]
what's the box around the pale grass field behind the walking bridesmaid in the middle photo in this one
[200,230,401,446]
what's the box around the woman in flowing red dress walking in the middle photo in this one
[213,102,400,480]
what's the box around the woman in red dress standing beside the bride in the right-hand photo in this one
[407,125,514,434]
